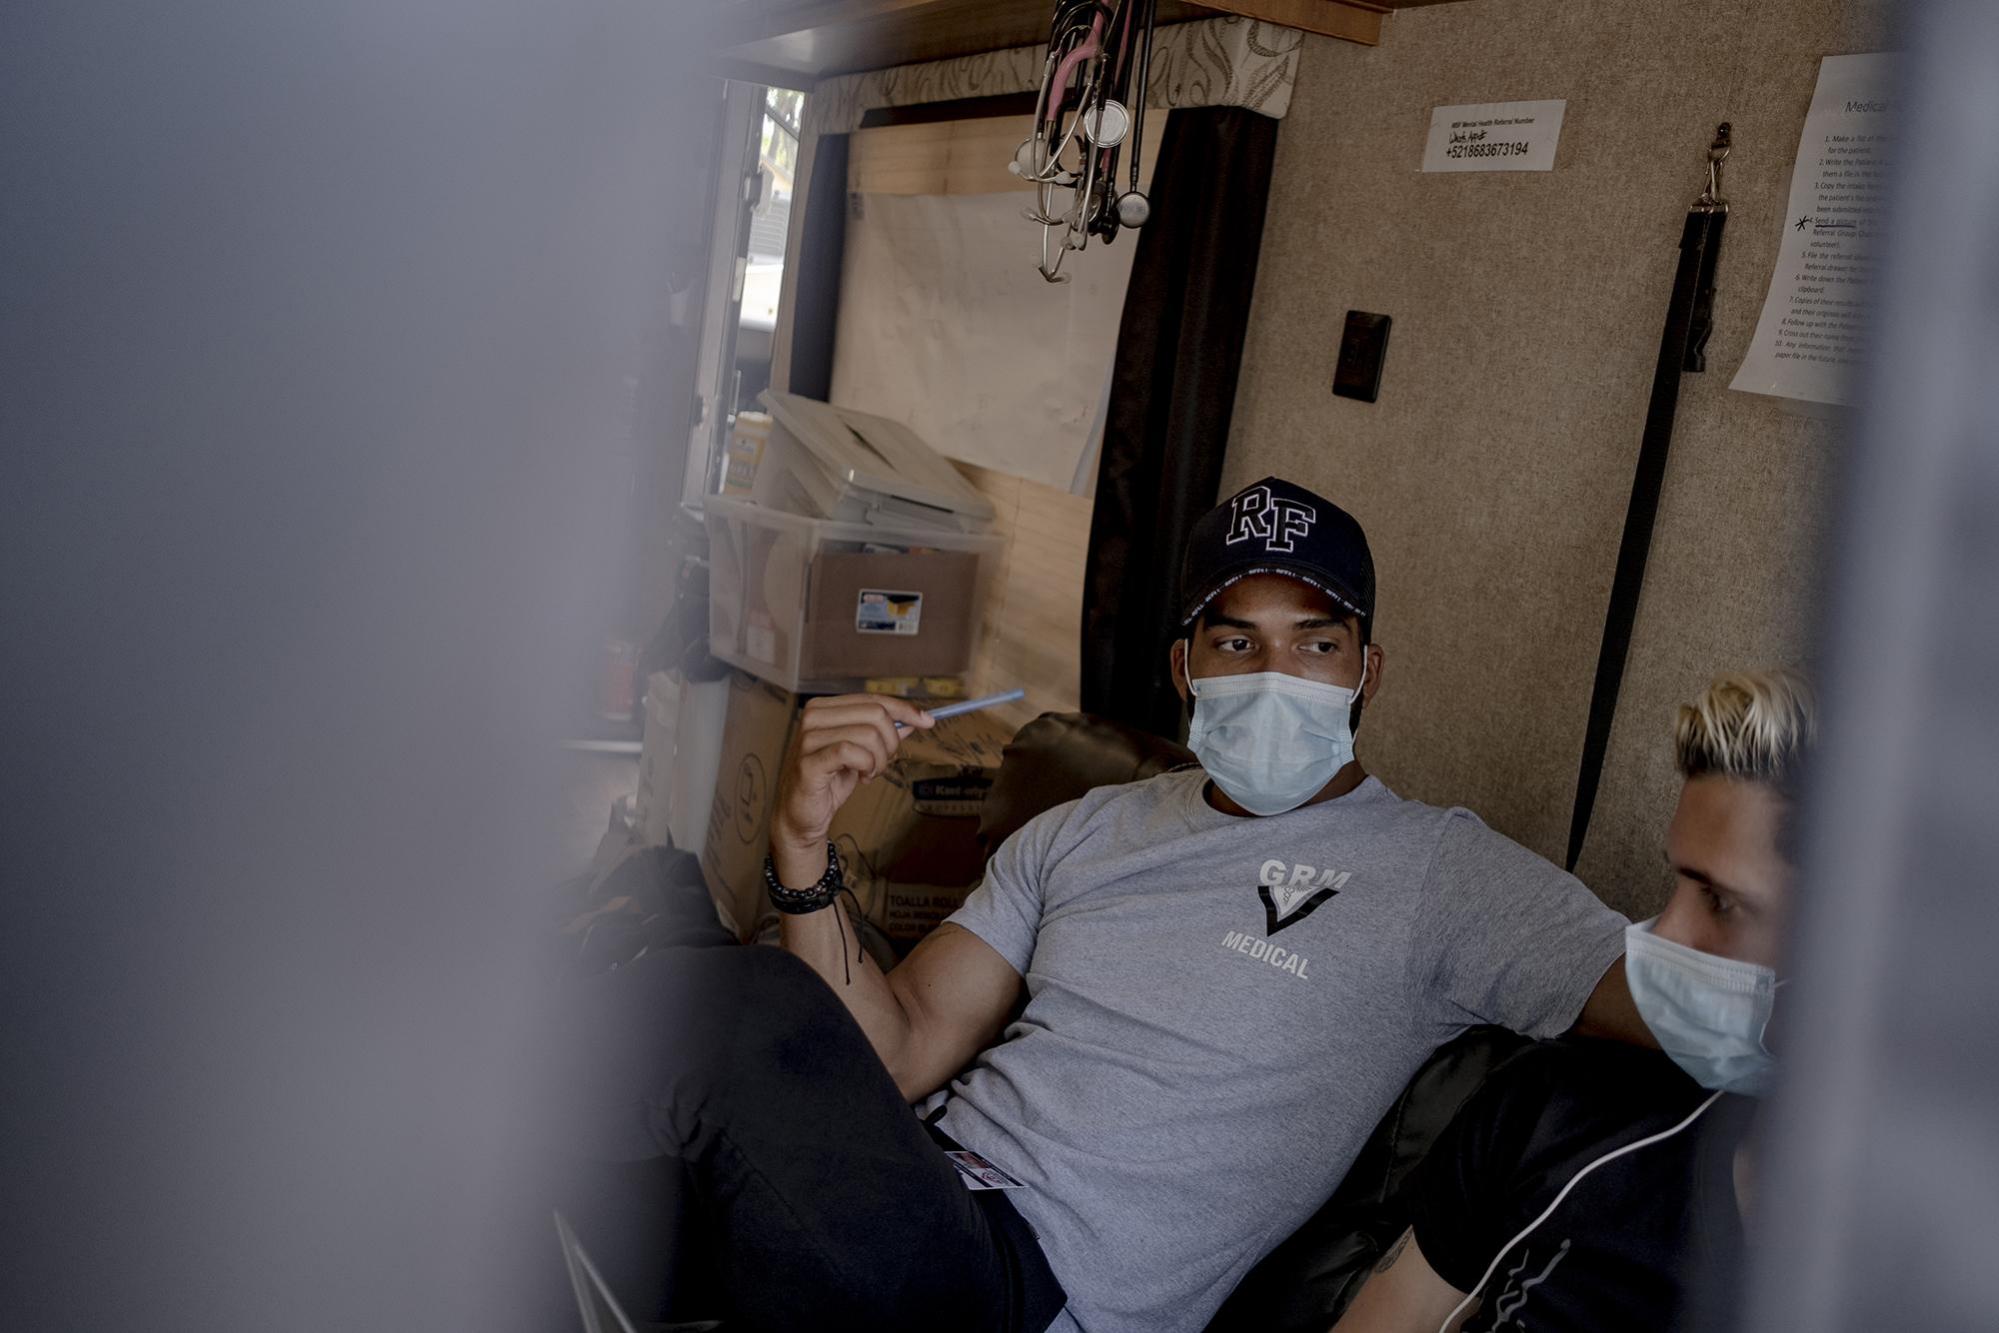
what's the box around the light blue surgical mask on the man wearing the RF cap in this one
[1187,662,1367,815]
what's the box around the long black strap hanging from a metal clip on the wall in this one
[1567,122,1729,871]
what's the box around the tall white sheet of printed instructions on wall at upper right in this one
[1729,54,1895,406]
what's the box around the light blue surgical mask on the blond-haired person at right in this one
[1625,917,1781,1097]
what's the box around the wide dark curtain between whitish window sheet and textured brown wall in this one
[1081,106,1277,735]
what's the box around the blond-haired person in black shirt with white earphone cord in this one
[1335,669,1815,1333]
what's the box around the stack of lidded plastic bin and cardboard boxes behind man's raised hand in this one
[674,394,1011,949]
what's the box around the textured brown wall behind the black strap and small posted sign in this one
[1223,0,1891,915]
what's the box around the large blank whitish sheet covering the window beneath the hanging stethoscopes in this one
[832,190,1137,490]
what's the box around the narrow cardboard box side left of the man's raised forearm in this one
[702,671,798,939]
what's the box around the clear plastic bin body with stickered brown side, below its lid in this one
[706,496,1003,693]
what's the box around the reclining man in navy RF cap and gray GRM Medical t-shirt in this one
[599,478,1647,1333]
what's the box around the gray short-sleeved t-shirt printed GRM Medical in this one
[928,769,1625,1333]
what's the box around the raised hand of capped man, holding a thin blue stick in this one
[770,693,934,889]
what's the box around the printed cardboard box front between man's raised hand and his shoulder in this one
[832,713,1013,951]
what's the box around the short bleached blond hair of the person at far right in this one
[1673,667,1817,797]
